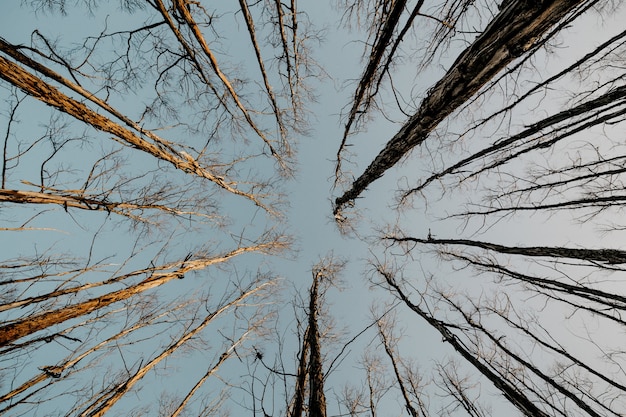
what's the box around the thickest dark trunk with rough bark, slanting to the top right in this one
[334,0,582,215]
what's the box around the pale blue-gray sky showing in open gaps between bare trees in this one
[0,1,623,415]
